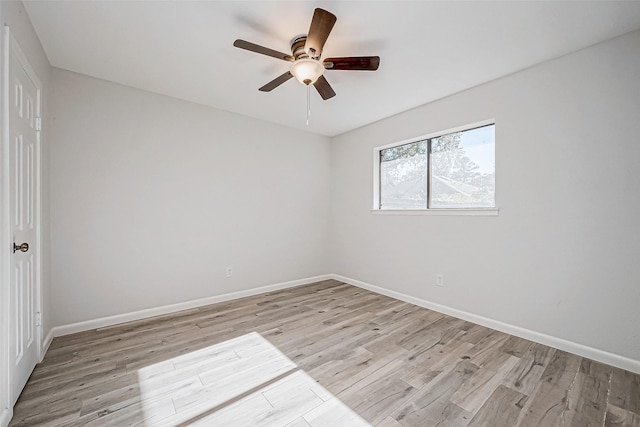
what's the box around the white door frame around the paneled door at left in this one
[0,25,44,418]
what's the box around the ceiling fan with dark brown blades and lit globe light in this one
[233,8,380,100]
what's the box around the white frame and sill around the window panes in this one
[371,119,500,216]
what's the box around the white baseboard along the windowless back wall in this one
[50,274,331,337]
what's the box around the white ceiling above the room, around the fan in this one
[24,0,640,136]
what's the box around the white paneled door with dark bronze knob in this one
[5,30,40,405]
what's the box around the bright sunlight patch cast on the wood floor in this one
[131,332,369,427]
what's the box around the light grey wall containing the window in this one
[331,32,640,360]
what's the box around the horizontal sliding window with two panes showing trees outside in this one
[374,122,495,210]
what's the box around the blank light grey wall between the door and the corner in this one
[51,69,330,325]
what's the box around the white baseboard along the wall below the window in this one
[329,274,640,374]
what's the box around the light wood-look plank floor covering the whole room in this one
[11,281,640,427]
